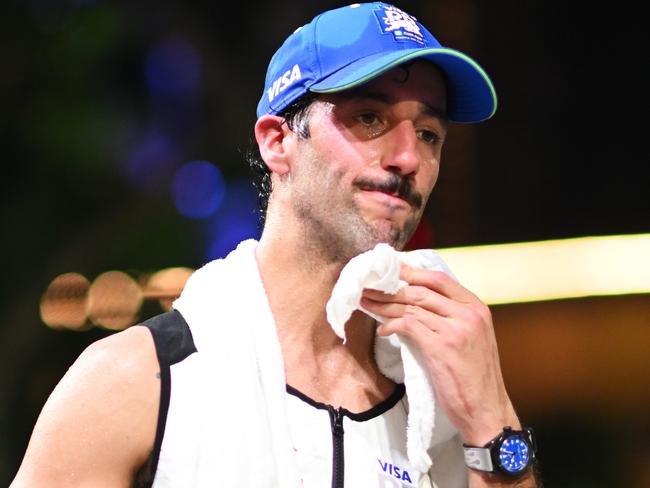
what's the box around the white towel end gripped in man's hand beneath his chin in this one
[326,244,455,472]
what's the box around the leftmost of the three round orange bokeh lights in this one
[40,273,90,329]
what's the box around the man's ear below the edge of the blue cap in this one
[255,115,293,176]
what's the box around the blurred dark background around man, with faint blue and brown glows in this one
[0,0,650,487]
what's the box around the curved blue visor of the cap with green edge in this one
[309,48,497,122]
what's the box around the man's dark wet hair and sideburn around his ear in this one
[245,93,317,228]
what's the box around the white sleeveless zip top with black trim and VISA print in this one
[138,311,468,488]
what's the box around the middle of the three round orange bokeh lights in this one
[87,271,143,330]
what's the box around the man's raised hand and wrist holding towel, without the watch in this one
[362,265,537,488]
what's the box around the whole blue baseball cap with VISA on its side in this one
[257,2,497,122]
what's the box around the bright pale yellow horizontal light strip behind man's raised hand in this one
[438,234,650,305]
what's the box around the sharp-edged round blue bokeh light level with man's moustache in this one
[172,161,226,219]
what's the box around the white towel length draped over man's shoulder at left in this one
[173,239,300,488]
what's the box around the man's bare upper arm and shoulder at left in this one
[11,327,160,488]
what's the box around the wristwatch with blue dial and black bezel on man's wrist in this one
[463,426,537,477]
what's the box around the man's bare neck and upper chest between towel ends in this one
[256,227,394,411]
